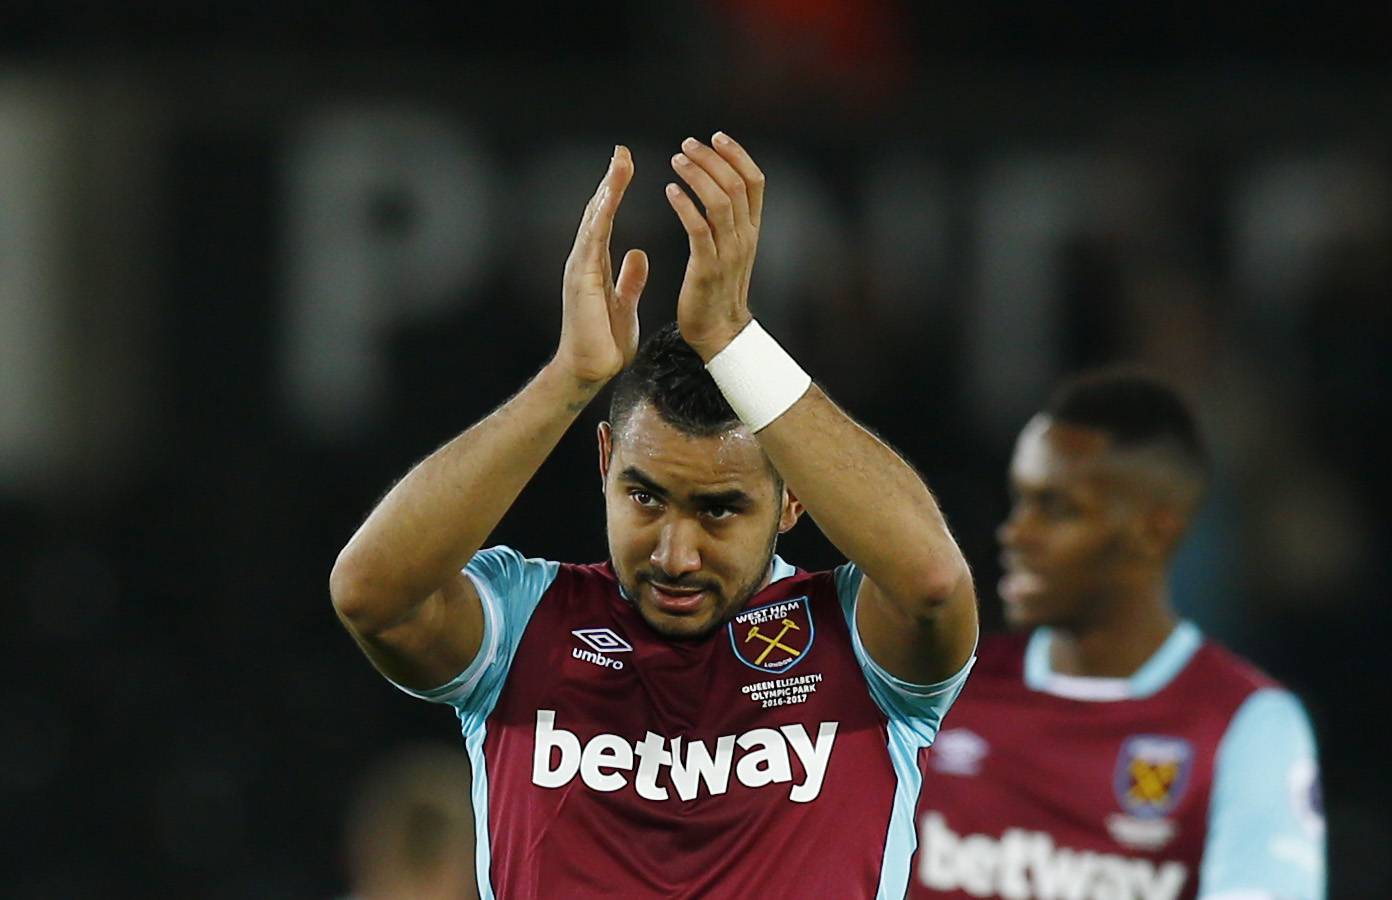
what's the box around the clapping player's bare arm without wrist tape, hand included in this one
[329,147,647,690]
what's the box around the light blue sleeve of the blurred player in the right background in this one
[1199,689,1325,900]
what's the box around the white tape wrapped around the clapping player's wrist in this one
[706,320,812,431]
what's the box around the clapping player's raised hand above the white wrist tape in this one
[667,132,764,360]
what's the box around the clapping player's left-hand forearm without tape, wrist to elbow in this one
[330,364,603,629]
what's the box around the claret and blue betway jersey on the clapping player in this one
[392,547,972,900]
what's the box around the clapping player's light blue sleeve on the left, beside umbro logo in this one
[386,547,561,730]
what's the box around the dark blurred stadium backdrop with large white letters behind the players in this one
[0,0,1392,900]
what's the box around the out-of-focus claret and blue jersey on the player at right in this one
[910,623,1325,900]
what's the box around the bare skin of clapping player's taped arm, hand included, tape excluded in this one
[667,135,977,684]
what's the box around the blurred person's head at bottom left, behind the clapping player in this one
[345,747,479,900]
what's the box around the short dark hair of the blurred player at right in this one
[1041,366,1208,479]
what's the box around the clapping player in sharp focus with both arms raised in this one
[330,134,976,900]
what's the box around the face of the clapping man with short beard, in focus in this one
[599,403,802,640]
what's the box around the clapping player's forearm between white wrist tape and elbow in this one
[759,384,970,616]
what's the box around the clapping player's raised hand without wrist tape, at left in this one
[555,146,647,384]
